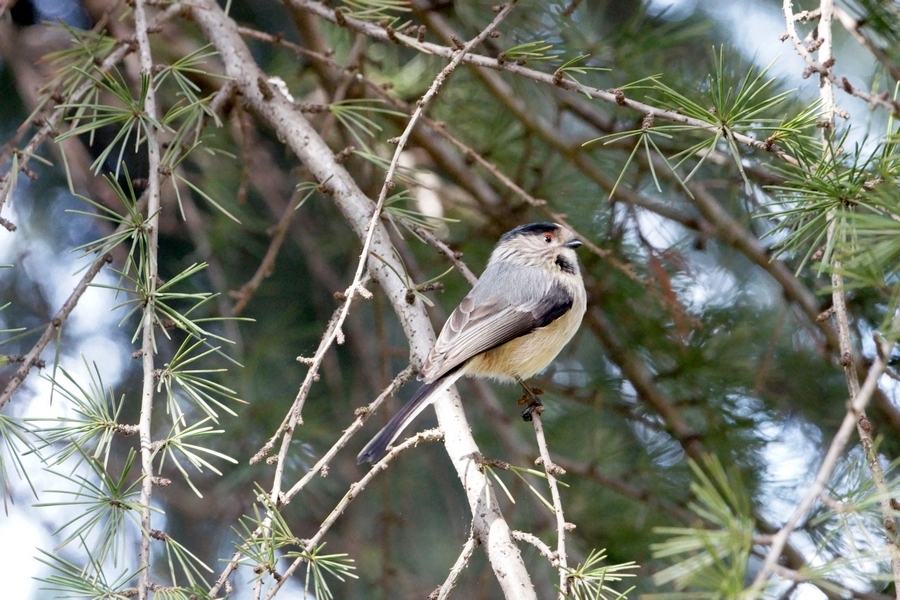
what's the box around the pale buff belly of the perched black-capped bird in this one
[465,310,582,381]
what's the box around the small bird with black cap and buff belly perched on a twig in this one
[356,223,587,463]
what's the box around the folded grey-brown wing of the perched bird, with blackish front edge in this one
[422,271,573,382]
